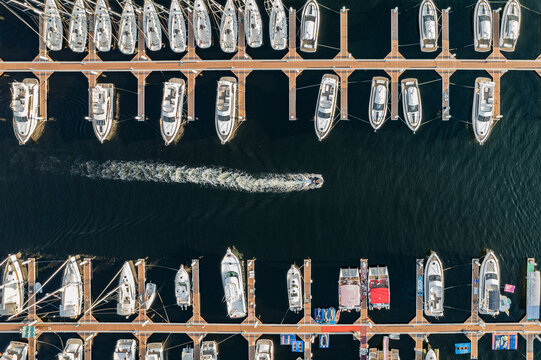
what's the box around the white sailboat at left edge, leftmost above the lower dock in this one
[0,255,26,316]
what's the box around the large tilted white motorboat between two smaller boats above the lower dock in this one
[221,248,246,319]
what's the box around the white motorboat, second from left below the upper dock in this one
[89,84,115,143]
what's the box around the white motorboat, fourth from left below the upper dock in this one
[215,77,237,144]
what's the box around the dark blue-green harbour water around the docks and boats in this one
[0,0,541,359]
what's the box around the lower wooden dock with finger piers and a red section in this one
[4,258,541,360]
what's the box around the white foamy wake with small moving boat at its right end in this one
[70,160,323,193]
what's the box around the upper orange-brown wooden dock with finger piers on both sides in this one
[0,8,541,131]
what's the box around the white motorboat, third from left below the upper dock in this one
[160,78,186,145]
